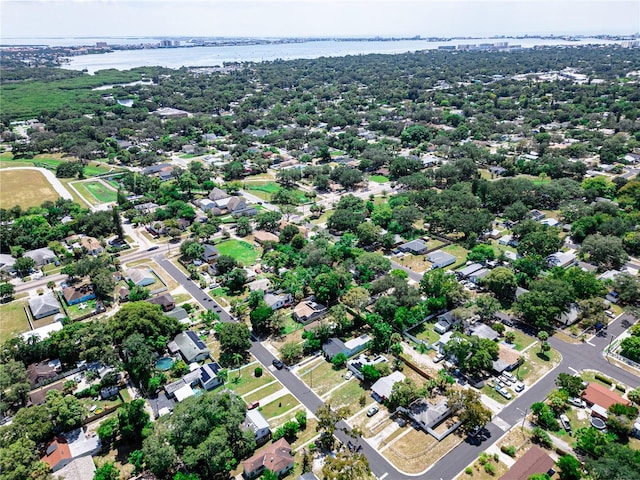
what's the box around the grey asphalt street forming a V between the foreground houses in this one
[154,251,640,480]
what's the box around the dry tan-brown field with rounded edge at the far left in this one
[0,170,59,209]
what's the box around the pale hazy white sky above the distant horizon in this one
[0,0,640,37]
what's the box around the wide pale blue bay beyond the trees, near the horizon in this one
[56,38,621,73]
